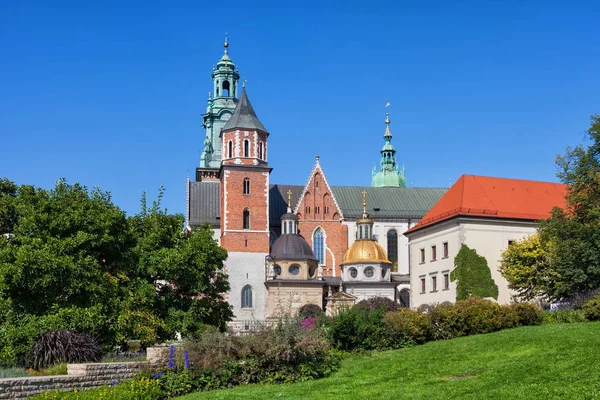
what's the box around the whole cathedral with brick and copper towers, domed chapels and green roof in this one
[186,41,447,329]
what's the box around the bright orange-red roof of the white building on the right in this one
[407,175,567,233]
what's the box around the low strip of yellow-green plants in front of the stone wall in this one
[31,378,165,400]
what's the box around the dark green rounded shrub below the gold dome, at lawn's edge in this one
[327,306,386,351]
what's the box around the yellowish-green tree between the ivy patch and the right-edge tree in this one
[499,233,556,301]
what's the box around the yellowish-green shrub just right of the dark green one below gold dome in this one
[383,308,431,349]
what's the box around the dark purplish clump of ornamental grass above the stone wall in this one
[29,331,102,370]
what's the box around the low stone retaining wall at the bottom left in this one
[0,362,147,399]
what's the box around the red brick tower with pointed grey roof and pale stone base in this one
[220,88,271,320]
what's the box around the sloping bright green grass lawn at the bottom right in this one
[179,322,600,400]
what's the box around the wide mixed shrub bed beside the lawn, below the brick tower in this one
[168,318,340,395]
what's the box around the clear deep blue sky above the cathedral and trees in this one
[0,1,600,214]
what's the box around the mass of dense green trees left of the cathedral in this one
[0,180,232,365]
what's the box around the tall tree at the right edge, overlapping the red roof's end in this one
[539,115,600,300]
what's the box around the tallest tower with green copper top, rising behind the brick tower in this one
[197,35,240,175]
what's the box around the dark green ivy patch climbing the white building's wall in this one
[450,244,498,300]
